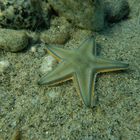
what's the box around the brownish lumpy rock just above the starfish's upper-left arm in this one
[40,17,71,44]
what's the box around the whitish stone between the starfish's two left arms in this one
[40,55,57,74]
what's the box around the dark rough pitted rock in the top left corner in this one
[0,0,50,30]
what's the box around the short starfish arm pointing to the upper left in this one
[47,45,73,61]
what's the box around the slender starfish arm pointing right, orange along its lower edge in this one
[96,58,129,72]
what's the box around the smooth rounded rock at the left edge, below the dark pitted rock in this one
[0,29,29,52]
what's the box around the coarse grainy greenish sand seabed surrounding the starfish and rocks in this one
[0,0,140,140]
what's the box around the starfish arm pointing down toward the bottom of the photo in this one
[74,69,96,107]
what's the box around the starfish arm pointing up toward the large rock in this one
[79,36,96,55]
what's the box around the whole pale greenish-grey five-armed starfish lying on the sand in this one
[38,36,129,107]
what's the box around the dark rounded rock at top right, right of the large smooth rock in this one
[104,0,130,22]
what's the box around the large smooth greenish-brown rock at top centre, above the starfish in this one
[48,0,104,31]
